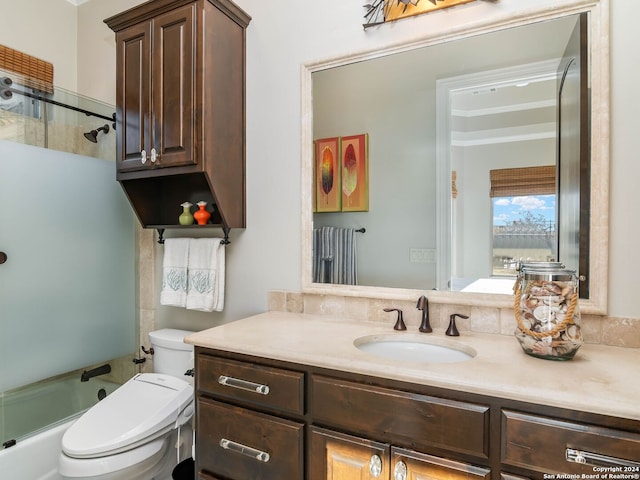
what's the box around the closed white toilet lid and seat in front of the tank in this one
[62,373,193,458]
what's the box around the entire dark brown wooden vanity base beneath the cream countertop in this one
[196,347,640,480]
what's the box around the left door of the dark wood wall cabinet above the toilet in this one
[116,22,151,172]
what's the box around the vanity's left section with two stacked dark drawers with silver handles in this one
[196,352,305,480]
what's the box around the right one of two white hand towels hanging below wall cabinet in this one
[187,238,225,312]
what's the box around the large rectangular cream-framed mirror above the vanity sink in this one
[302,2,609,313]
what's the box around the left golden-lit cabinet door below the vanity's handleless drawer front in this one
[308,427,389,480]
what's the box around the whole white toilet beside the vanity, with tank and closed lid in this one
[58,329,194,480]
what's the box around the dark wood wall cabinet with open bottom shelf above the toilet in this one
[105,0,250,228]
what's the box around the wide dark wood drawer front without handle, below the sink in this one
[310,375,489,458]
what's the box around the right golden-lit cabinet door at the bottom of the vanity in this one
[391,447,491,480]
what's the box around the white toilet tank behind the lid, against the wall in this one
[149,328,193,380]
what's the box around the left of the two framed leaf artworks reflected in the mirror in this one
[314,137,342,212]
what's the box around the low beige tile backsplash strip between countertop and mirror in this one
[269,290,640,348]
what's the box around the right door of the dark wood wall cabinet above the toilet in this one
[150,4,196,168]
